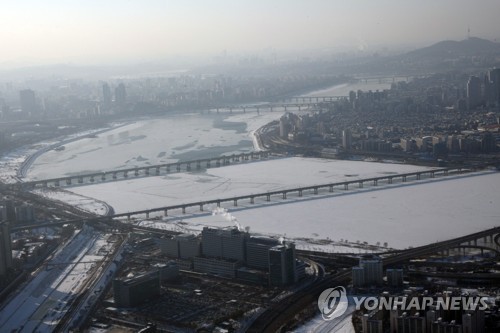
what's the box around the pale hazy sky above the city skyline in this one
[0,0,500,66]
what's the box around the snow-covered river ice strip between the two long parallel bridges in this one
[68,157,434,213]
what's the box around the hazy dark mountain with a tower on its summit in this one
[403,37,500,59]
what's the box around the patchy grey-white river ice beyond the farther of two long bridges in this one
[27,111,296,179]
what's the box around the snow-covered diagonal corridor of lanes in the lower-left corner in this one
[0,228,116,332]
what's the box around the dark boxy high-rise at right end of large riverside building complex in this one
[269,243,297,286]
